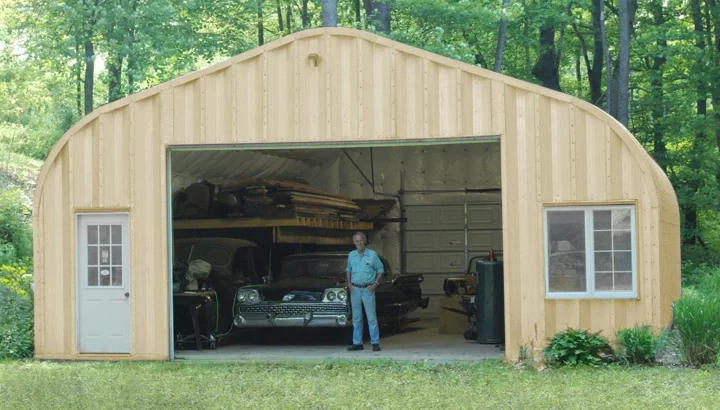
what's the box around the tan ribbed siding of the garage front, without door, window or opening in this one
[33,28,680,360]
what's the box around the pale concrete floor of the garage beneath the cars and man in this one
[175,320,504,363]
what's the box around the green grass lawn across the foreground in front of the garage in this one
[0,361,720,409]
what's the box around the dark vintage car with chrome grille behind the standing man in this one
[234,253,429,328]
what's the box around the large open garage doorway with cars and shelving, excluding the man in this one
[168,137,504,360]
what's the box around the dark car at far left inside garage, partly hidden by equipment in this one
[173,237,269,347]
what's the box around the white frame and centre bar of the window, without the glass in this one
[543,204,638,299]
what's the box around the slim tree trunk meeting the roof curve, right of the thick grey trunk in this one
[648,0,667,173]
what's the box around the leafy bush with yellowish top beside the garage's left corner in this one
[0,265,34,359]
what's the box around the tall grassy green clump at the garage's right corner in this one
[675,270,720,366]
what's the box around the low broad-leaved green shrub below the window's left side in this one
[544,328,613,366]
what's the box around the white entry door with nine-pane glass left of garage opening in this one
[77,214,130,353]
